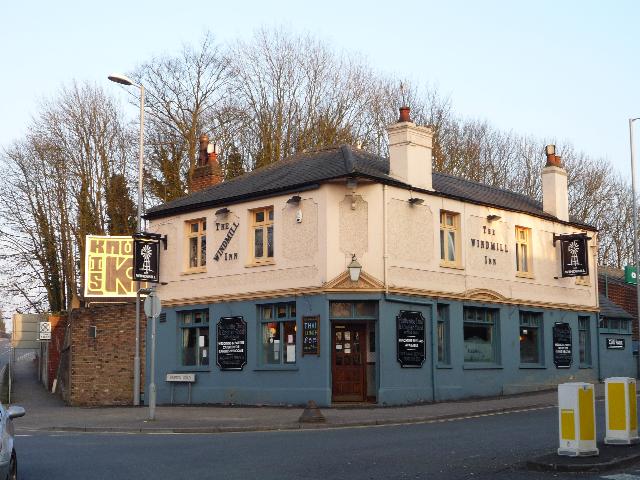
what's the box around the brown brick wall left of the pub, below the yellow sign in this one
[68,302,146,406]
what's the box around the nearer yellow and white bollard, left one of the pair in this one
[558,382,599,457]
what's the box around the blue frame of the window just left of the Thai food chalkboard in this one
[256,302,302,370]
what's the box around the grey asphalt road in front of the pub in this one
[17,407,640,480]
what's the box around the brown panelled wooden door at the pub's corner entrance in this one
[331,323,367,402]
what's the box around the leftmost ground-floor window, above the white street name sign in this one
[178,310,209,367]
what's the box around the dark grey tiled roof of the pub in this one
[146,145,594,230]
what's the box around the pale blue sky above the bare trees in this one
[0,0,640,175]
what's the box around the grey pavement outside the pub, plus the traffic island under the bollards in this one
[11,360,640,472]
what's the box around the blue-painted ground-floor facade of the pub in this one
[146,292,620,406]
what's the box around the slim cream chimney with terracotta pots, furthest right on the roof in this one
[542,145,569,222]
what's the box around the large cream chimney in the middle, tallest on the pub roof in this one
[387,107,433,190]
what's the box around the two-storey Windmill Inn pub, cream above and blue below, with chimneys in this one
[146,107,631,406]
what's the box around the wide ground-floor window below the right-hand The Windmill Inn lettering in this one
[464,307,499,363]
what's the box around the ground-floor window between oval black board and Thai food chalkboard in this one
[259,302,297,365]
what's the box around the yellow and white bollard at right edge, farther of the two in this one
[604,377,640,445]
